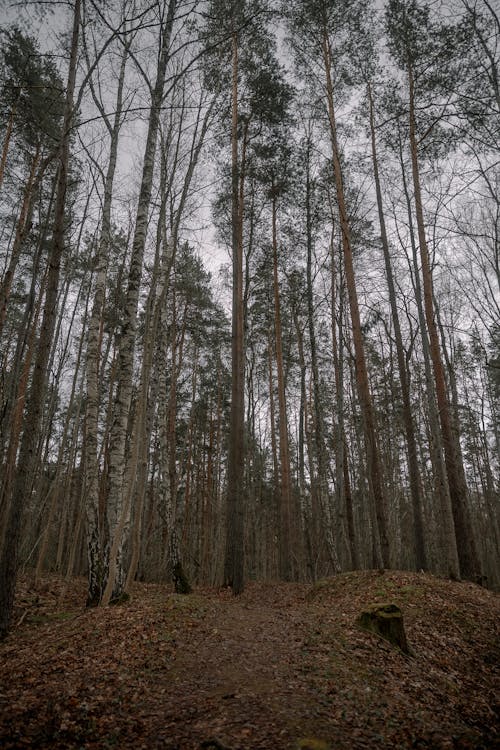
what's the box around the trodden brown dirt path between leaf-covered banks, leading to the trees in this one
[148,587,313,748]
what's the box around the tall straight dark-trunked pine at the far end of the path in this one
[204,0,276,594]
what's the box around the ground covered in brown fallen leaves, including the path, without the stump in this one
[0,571,500,750]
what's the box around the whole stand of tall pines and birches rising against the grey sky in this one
[0,0,500,637]
